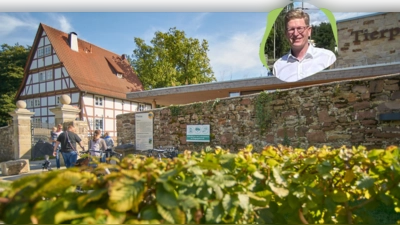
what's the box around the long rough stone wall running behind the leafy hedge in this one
[117,74,400,151]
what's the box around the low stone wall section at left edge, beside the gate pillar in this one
[0,126,14,162]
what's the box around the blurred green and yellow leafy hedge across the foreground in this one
[0,145,400,224]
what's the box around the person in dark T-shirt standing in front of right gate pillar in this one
[53,124,85,168]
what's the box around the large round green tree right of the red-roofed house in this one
[129,27,216,90]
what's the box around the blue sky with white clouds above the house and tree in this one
[0,3,374,81]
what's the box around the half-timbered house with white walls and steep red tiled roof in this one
[16,23,151,137]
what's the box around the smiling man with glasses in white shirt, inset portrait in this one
[273,9,336,82]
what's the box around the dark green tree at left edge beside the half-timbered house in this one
[0,43,31,126]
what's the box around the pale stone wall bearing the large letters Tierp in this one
[335,12,400,68]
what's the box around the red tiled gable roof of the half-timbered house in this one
[17,23,143,99]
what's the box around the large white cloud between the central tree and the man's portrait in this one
[208,27,268,81]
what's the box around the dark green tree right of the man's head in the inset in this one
[311,22,335,52]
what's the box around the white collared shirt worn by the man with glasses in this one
[273,44,336,82]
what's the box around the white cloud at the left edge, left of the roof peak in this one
[0,13,38,37]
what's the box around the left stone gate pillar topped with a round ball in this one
[9,100,35,159]
